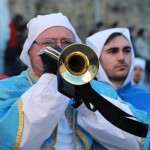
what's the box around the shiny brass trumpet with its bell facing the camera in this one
[39,44,99,85]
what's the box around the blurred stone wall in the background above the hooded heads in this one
[9,0,150,40]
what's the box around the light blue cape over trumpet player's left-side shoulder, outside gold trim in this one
[0,72,30,150]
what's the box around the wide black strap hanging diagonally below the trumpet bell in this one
[76,83,148,137]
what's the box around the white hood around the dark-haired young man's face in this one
[86,28,134,86]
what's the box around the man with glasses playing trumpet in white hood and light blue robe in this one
[0,13,148,150]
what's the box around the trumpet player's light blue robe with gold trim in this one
[0,71,149,150]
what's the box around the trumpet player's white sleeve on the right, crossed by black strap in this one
[77,96,141,150]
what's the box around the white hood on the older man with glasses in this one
[20,13,81,71]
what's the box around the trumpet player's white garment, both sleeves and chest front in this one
[20,74,140,150]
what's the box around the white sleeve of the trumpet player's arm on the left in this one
[20,74,70,150]
